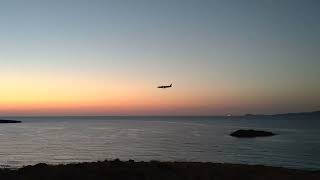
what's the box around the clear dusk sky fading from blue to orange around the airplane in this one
[0,0,320,115]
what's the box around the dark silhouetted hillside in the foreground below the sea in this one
[0,160,320,180]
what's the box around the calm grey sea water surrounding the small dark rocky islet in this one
[0,117,320,170]
